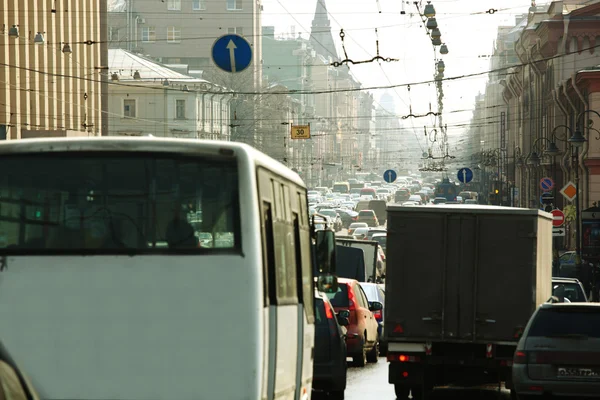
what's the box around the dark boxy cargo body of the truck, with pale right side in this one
[384,205,552,343]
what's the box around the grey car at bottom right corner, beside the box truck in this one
[512,303,600,399]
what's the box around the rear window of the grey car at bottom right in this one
[528,307,600,338]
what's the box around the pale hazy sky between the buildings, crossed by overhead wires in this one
[263,0,542,154]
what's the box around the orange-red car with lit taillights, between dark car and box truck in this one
[327,278,383,367]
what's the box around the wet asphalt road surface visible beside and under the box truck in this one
[338,357,510,400]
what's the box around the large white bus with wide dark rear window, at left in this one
[0,137,334,400]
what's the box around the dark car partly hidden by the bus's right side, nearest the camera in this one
[313,290,350,400]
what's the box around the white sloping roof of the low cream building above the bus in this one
[108,49,210,83]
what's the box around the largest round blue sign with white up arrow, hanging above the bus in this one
[212,35,252,72]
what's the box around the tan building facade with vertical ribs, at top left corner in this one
[0,0,108,140]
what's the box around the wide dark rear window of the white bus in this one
[0,152,240,254]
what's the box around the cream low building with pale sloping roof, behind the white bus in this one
[108,49,233,140]
